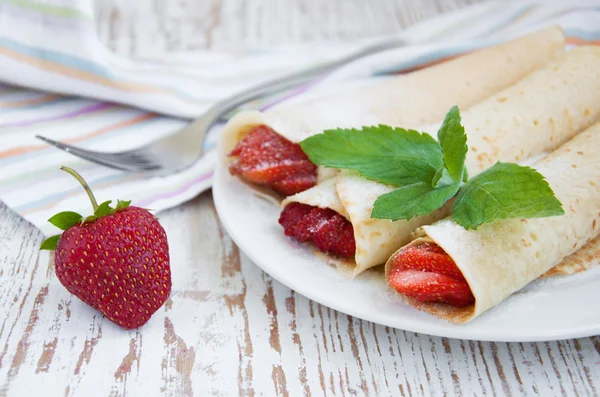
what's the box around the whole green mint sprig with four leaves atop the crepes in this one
[300,106,564,229]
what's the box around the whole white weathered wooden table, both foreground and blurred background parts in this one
[0,0,600,396]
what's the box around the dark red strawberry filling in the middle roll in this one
[279,203,356,258]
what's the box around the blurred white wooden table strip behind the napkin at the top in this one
[96,0,481,57]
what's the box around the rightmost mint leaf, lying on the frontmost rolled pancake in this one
[452,163,564,229]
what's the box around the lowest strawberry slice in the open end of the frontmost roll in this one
[388,270,475,307]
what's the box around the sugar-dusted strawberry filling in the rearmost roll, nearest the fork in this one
[229,125,317,196]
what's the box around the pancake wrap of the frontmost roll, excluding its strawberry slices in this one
[386,124,600,323]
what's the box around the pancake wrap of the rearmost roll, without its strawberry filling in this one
[219,27,564,195]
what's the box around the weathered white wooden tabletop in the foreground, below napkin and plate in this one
[0,194,600,396]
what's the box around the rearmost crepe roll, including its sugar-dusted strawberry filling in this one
[220,28,564,198]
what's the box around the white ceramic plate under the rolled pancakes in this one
[213,161,600,342]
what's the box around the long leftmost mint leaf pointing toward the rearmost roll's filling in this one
[300,125,443,186]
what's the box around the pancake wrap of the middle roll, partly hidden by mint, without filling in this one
[283,46,600,274]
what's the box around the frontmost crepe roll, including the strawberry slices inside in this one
[386,124,600,323]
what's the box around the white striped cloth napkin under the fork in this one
[0,0,600,234]
